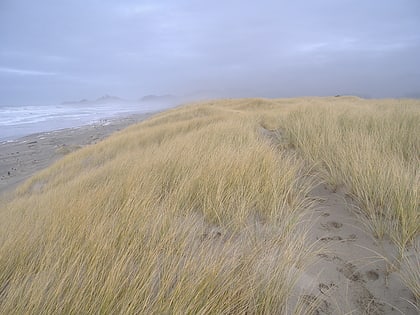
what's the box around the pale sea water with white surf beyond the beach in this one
[0,102,173,143]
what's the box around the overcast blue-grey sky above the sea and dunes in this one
[0,0,420,105]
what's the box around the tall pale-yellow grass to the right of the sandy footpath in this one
[282,98,420,249]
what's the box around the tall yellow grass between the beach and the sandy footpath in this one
[0,102,316,314]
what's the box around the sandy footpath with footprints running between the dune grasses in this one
[300,184,418,315]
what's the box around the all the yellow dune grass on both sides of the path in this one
[0,98,420,314]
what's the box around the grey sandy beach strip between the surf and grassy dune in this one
[0,111,159,197]
